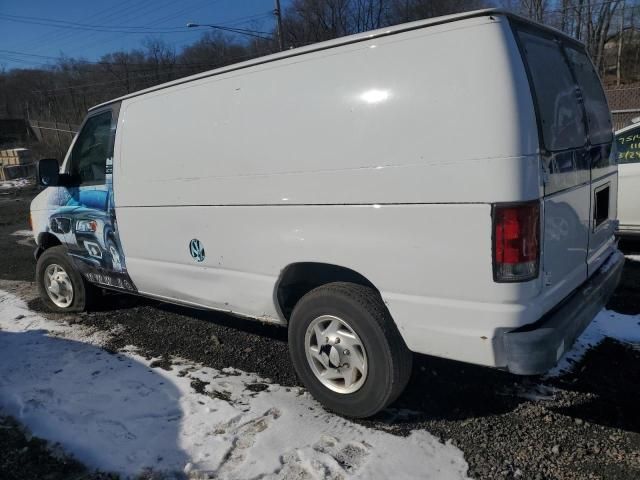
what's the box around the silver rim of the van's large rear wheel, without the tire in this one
[305,315,368,394]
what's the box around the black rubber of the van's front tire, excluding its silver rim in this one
[36,246,98,312]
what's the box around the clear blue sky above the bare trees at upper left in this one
[0,0,289,69]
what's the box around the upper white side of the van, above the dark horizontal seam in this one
[116,17,540,207]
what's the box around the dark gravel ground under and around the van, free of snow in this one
[0,182,640,480]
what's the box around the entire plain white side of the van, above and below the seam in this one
[114,16,542,365]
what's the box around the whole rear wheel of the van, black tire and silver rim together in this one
[289,282,413,418]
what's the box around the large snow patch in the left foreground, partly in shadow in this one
[0,290,467,479]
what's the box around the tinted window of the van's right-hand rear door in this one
[566,47,613,145]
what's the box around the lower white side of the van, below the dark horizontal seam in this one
[118,204,541,365]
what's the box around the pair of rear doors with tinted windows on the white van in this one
[515,24,617,297]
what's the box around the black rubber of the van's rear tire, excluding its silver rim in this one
[289,282,413,418]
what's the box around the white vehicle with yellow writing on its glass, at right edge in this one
[614,122,640,238]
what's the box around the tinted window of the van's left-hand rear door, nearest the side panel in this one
[518,31,586,151]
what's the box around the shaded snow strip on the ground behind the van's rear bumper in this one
[545,309,640,378]
